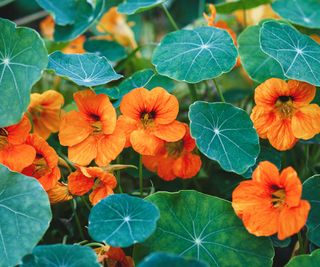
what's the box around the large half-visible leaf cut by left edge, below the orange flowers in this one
[0,164,51,266]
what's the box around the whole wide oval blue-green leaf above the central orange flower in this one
[152,27,238,83]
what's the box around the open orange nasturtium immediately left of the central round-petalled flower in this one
[59,90,126,166]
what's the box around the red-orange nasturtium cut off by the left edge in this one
[0,116,36,172]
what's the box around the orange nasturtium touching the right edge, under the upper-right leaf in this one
[251,78,320,150]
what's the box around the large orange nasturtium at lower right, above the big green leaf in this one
[232,161,310,240]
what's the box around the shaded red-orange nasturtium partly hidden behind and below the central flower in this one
[142,124,201,181]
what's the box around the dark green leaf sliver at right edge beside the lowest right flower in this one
[302,174,320,246]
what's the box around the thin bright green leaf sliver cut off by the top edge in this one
[216,0,272,14]
